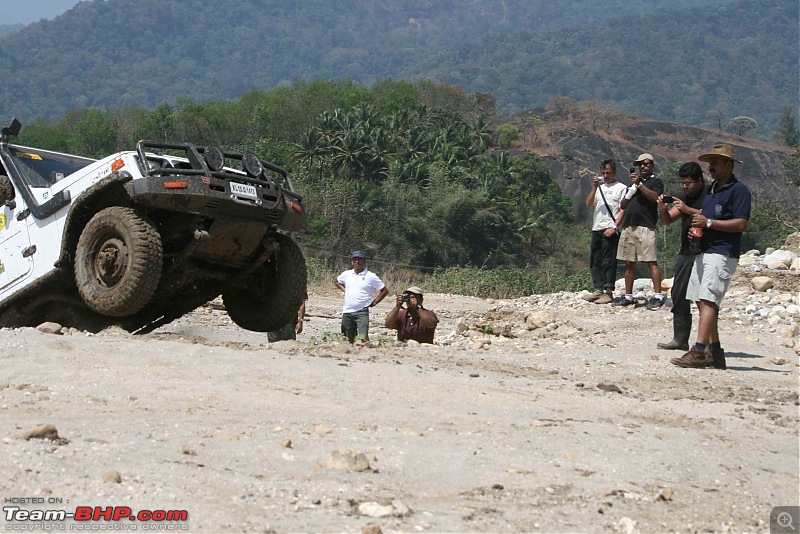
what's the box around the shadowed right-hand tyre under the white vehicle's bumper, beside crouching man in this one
[222,234,306,332]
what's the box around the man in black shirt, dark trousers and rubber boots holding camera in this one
[658,161,706,350]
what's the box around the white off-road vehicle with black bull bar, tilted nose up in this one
[0,119,306,332]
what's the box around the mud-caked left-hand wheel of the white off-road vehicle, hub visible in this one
[75,206,163,317]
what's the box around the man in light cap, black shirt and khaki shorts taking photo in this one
[612,154,664,310]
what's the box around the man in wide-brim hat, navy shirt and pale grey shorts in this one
[671,144,751,369]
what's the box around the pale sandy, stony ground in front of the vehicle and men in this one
[0,282,800,532]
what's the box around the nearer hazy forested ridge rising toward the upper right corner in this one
[432,0,799,135]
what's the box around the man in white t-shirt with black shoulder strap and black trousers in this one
[583,159,627,304]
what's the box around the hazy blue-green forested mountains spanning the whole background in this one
[0,0,798,136]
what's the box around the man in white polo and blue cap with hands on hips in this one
[333,250,389,343]
